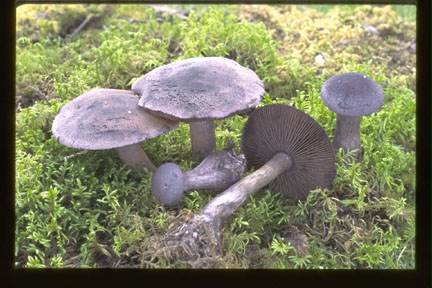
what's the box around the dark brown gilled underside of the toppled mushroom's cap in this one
[241,104,336,200]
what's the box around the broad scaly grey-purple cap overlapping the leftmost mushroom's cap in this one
[132,57,264,122]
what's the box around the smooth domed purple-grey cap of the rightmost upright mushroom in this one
[321,72,384,117]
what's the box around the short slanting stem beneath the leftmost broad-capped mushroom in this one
[115,143,156,172]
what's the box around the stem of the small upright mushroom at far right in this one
[333,114,361,152]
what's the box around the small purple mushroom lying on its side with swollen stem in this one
[152,150,246,206]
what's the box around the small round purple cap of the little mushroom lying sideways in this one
[152,163,184,206]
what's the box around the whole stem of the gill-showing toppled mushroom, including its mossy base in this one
[149,153,293,262]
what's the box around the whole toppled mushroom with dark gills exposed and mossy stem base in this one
[150,104,336,261]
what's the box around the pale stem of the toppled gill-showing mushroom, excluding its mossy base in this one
[197,152,293,226]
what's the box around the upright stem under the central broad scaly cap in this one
[189,120,216,161]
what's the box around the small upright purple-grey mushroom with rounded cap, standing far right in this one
[321,72,384,161]
